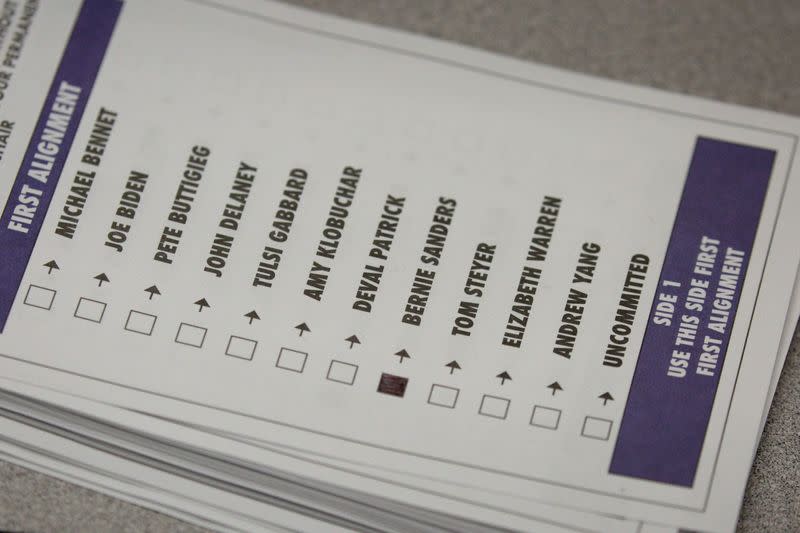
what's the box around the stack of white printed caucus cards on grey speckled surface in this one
[0,0,800,533]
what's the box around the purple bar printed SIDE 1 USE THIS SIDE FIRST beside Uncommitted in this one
[609,137,775,487]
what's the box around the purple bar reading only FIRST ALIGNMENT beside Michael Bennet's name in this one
[0,0,122,333]
